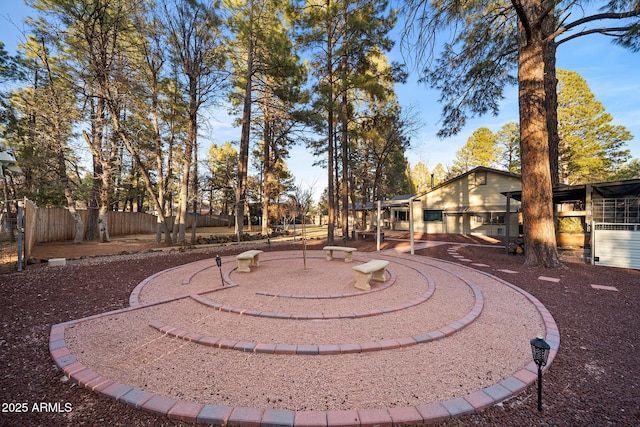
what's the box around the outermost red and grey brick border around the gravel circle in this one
[49,252,560,427]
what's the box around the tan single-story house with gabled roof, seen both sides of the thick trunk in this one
[376,167,640,269]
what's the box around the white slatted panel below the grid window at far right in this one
[593,223,640,270]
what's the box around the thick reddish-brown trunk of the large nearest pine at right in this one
[518,0,562,267]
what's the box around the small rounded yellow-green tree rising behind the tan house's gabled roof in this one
[451,127,498,175]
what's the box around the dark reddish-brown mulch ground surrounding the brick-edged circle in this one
[0,236,640,426]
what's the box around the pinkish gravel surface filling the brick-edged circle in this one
[58,251,544,411]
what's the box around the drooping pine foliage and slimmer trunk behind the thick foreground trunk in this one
[403,0,640,184]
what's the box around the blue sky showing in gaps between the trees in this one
[0,0,640,201]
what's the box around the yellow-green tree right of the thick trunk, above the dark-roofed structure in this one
[557,70,633,185]
